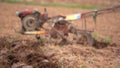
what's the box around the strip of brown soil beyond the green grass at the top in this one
[36,0,120,6]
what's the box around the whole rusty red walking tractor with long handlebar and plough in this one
[16,5,120,45]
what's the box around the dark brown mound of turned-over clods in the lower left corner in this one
[0,37,58,68]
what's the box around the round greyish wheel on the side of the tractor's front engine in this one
[22,15,39,31]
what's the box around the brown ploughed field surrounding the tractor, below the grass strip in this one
[0,1,120,68]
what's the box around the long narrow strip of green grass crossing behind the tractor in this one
[0,0,102,9]
